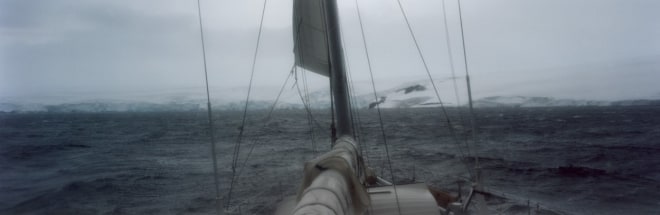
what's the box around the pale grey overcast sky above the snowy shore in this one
[0,0,660,103]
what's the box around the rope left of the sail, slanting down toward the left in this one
[227,0,267,207]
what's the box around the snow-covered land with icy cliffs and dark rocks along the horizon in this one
[0,81,660,112]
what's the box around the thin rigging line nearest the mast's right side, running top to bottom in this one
[355,0,401,215]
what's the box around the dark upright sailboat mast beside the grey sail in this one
[323,0,353,137]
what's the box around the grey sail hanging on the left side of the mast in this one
[293,0,330,77]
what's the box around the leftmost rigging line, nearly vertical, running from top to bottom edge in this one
[197,0,222,214]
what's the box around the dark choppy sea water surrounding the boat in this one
[0,106,660,214]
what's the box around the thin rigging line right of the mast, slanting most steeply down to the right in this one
[397,0,473,178]
